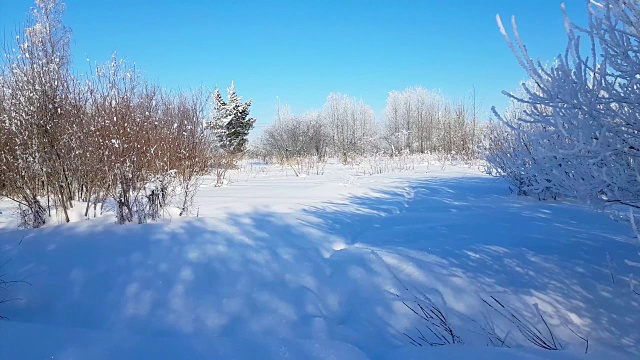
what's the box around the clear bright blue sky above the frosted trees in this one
[0,0,586,132]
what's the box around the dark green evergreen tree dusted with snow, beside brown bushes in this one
[205,82,256,186]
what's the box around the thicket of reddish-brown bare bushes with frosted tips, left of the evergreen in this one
[0,0,211,227]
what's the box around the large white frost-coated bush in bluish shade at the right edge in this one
[486,0,640,207]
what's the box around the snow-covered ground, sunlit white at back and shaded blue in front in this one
[0,164,640,359]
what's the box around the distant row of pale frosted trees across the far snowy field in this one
[254,87,482,172]
